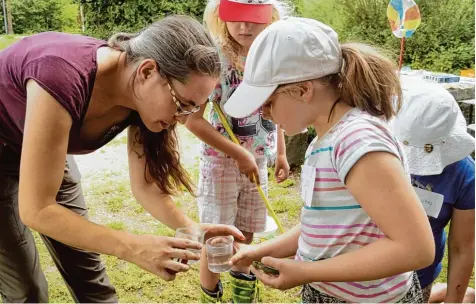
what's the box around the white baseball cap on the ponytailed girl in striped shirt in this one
[224,17,342,118]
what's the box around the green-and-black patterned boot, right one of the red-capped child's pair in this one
[230,270,258,303]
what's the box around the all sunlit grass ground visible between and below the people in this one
[5,125,474,303]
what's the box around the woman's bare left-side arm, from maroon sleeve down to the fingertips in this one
[19,80,201,280]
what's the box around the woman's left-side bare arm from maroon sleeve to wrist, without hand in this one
[19,80,127,256]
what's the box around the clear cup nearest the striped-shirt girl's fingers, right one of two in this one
[206,236,233,273]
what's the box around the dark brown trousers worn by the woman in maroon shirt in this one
[0,144,117,303]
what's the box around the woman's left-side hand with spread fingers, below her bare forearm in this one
[124,235,202,281]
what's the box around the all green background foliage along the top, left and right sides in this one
[0,0,475,74]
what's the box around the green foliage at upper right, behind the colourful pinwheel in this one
[299,0,475,74]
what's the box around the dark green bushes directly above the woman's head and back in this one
[83,0,206,39]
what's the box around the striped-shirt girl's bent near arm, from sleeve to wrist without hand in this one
[308,152,435,282]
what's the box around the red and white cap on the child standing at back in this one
[218,0,273,24]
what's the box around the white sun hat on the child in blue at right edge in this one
[392,77,475,175]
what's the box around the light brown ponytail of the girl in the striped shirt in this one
[335,44,402,121]
